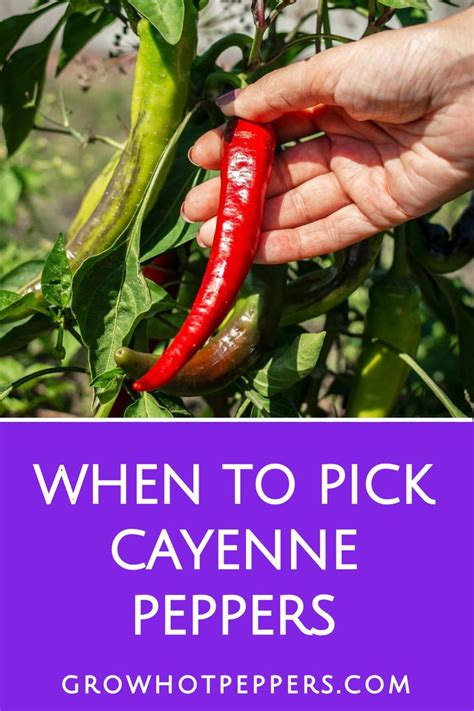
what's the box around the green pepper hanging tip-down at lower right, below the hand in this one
[346,226,421,417]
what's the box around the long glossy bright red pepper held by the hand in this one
[133,118,276,392]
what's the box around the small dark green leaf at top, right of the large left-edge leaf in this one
[56,7,115,76]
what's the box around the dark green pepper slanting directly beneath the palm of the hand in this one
[281,234,383,326]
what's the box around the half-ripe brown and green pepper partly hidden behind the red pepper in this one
[115,265,286,396]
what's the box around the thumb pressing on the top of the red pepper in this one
[216,45,352,122]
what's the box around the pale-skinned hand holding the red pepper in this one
[182,8,474,263]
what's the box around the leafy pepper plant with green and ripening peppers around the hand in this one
[0,0,474,418]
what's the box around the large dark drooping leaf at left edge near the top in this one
[0,18,64,155]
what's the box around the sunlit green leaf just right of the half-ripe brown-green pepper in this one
[252,331,326,397]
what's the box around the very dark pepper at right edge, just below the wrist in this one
[407,197,474,274]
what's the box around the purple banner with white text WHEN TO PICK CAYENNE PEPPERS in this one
[0,421,473,711]
